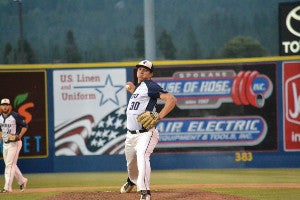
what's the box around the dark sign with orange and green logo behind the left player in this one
[0,71,48,158]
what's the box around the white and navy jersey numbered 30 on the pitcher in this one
[126,80,167,131]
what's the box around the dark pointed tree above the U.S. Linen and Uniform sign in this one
[65,30,81,63]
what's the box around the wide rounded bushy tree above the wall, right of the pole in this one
[220,36,267,58]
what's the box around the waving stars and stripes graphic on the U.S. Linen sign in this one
[54,106,126,156]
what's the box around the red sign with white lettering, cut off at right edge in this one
[282,62,300,151]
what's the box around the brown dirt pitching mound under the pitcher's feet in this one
[43,190,247,200]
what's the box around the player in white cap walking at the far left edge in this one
[0,98,28,193]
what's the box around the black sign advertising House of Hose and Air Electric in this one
[137,63,278,152]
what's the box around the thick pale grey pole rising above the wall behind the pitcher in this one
[144,0,156,61]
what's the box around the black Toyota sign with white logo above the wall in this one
[279,2,300,56]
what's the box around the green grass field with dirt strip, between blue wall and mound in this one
[0,169,300,200]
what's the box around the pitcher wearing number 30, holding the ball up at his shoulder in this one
[120,60,177,200]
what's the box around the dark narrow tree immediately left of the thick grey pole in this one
[133,25,145,58]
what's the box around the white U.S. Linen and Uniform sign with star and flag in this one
[53,69,127,156]
